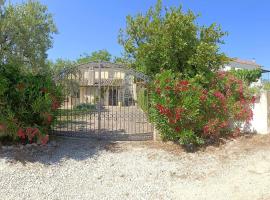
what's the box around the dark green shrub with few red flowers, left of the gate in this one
[0,66,63,144]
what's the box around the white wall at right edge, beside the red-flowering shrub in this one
[247,91,270,134]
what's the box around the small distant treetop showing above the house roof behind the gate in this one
[77,49,112,64]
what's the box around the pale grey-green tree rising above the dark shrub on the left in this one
[0,1,57,72]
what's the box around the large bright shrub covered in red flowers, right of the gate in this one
[150,70,255,144]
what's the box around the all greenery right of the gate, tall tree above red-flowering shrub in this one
[119,0,260,144]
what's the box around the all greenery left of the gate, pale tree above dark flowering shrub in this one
[0,1,63,144]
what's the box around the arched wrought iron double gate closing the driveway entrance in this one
[53,62,153,140]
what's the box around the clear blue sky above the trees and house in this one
[11,0,270,69]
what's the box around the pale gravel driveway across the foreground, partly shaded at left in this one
[0,136,270,200]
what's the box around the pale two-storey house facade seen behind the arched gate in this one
[62,62,138,107]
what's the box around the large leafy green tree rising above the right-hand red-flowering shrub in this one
[119,0,227,77]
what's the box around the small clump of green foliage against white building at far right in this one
[230,69,262,85]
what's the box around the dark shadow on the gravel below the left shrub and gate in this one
[0,137,119,165]
